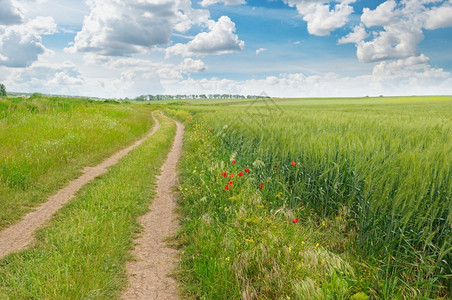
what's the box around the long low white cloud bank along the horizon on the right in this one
[163,61,452,97]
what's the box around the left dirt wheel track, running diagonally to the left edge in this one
[0,114,160,259]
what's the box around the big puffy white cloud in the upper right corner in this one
[338,0,452,62]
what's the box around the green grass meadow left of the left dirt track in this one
[0,98,154,230]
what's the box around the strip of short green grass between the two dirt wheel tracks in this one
[0,112,176,299]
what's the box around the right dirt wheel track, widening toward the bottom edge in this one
[123,116,184,300]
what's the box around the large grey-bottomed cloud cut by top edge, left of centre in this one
[68,0,210,56]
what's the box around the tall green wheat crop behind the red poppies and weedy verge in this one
[171,101,452,298]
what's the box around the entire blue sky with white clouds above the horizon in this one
[0,0,452,97]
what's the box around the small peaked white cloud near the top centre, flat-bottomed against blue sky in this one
[166,16,245,56]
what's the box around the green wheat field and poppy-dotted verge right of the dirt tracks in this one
[169,98,452,299]
